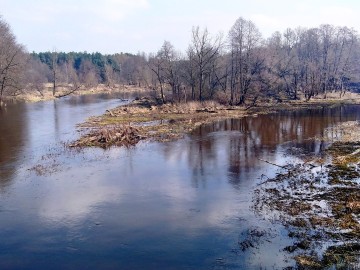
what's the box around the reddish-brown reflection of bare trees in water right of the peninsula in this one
[186,106,359,190]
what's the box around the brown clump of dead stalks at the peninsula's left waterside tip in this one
[70,125,143,148]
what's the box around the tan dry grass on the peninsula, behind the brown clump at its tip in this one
[72,97,360,150]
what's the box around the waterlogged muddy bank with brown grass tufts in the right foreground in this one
[253,122,360,269]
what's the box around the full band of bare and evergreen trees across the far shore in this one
[0,17,360,105]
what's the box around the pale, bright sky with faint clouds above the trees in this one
[0,0,360,53]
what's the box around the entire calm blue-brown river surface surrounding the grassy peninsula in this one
[0,95,360,269]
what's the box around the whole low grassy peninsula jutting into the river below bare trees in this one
[71,93,360,148]
